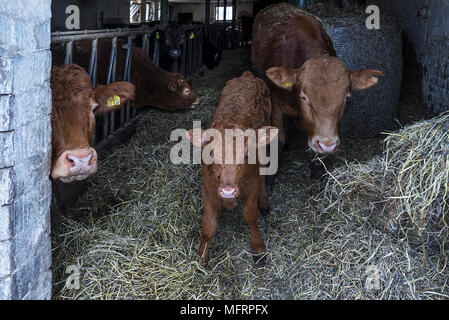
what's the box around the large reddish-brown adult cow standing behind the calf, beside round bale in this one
[252,3,384,154]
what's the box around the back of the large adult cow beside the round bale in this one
[251,3,336,79]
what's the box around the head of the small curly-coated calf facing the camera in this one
[186,126,278,199]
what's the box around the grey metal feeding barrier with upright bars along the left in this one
[51,24,240,146]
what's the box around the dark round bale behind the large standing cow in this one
[308,6,402,137]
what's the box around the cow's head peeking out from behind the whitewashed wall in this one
[51,64,135,182]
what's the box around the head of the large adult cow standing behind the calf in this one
[266,57,384,154]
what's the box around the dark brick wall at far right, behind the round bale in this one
[371,0,449,113]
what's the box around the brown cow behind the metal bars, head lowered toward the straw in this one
[51,39,200,111]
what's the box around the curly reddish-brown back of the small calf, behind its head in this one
[211,71,271,130]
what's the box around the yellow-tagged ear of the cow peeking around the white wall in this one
[95,81,136,115]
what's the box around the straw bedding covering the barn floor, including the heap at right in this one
[52,49,449,299]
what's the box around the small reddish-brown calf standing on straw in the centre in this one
[187,71,277,265]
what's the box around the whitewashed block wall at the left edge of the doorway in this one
[0,0,51,299]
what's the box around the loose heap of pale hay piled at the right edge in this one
[315,113,449,264]
